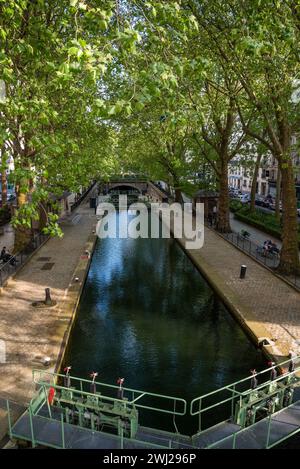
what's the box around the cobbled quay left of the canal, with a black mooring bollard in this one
[0,193,96,416]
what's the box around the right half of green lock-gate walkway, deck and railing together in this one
[190,357,300,449]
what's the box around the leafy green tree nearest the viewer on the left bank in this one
[0,0,137,250]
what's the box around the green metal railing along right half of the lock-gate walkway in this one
[190,356,300,433]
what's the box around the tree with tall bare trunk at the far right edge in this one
[184,0,299,274]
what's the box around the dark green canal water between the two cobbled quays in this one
[65,212,265,434]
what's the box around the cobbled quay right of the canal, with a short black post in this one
[180,228,300,356]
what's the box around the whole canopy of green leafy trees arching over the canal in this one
[0,0,300,272]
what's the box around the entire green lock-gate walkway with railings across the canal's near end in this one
[7,357,300,449]
